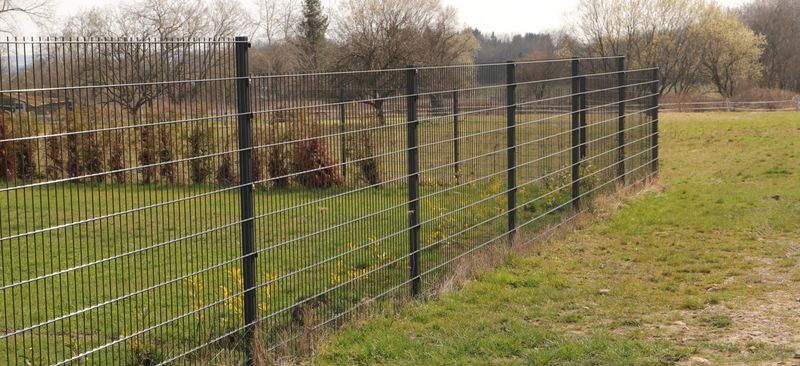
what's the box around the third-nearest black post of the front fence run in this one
[506,61,517,244]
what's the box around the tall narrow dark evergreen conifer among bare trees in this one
[299,0,328,70]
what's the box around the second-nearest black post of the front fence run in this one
[406,66,420,296]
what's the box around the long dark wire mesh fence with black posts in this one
[0,38,658,364]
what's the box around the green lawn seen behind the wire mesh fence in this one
[0,113,648,364]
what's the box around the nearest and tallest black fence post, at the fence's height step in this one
[235,37,258,363]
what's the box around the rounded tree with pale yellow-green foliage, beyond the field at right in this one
[696,5,765,98]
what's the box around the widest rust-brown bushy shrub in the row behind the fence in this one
[292,114,342,188]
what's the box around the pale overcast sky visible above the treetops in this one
[20,0,747,35]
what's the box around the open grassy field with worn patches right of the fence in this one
[313,113,800,365]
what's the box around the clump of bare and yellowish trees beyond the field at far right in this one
[559,0,800,98]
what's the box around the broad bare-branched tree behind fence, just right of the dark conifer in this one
[333,0,478,124]
